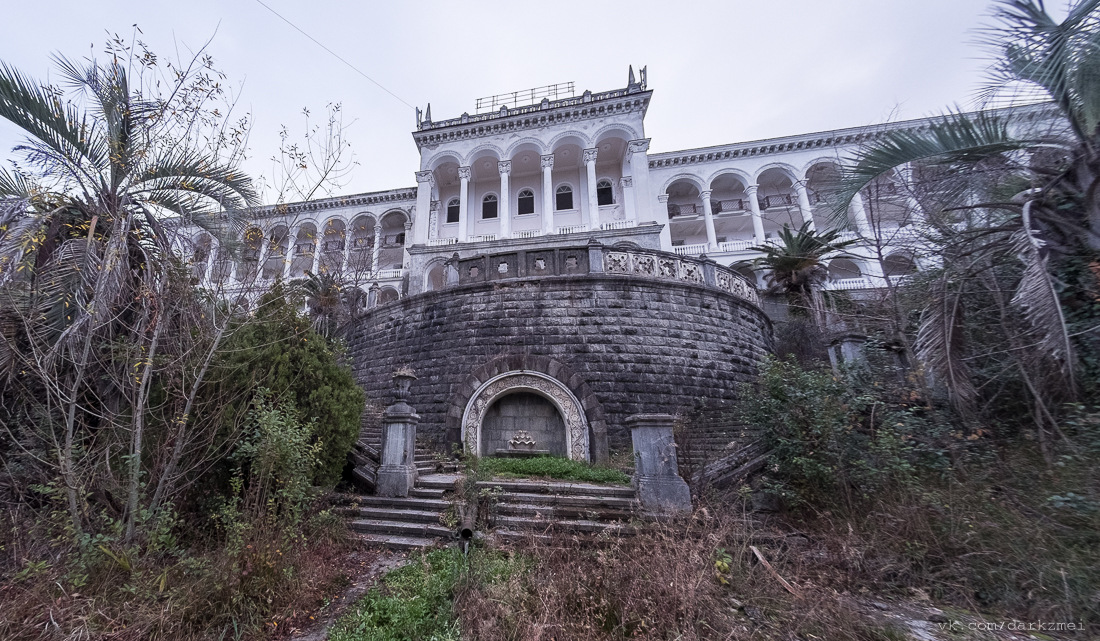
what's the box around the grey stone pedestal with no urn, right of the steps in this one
[626,415,691,515]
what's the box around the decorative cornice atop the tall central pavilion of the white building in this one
[413,89,653,150]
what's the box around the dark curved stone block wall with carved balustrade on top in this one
[349,245,771,461]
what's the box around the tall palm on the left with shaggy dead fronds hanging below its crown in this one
[0,52,256,537]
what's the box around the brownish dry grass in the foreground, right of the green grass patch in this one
[455,509,892,641]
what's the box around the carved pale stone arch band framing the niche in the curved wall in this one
[462,371,590,461]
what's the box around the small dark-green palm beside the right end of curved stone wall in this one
[751,222,855,325]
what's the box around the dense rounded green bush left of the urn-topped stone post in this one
[205,286,364,486]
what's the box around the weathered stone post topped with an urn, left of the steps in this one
[375,373,420,496]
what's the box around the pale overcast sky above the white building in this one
[0,0,1007,200]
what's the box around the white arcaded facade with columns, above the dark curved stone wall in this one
[182,73,1056,305]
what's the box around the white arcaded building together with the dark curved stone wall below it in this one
[180,69,1038,481]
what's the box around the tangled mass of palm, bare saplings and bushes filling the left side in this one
[0,38,363,640]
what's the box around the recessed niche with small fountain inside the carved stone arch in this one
[479,391,568,456]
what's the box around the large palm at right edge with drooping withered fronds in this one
[834,0,1100,460]
